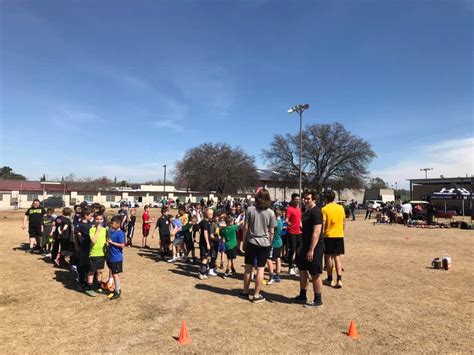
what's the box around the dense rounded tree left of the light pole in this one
[175,143,258,194]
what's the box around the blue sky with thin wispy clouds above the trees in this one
[0,0,474,186]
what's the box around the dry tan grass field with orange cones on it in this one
[0,210,474,353]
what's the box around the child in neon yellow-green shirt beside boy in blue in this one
[86,214,107,297]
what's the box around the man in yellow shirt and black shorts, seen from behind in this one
[321,191,346,288]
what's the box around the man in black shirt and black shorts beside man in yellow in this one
[293,191,324,307]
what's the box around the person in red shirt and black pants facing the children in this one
[285,193,301,275]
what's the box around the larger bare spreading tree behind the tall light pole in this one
[263,122,376,192]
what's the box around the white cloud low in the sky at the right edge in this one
[371,137,474,188]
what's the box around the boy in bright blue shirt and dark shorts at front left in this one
[107,216,125,300]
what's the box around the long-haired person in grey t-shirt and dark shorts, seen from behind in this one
[242,189,276,303]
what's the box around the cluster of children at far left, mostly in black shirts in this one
[23,200,125,300]
